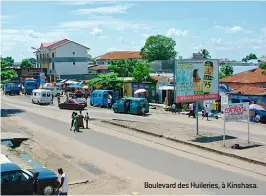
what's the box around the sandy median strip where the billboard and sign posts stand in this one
[103,120,266,166]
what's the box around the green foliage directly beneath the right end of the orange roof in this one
[108,59,138,77]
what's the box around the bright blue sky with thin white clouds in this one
[1,1,266,62]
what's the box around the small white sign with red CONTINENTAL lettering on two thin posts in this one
[224,102,249,122]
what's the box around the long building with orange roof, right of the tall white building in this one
[94,51,142,66]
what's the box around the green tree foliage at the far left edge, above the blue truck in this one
[1,57,18,83]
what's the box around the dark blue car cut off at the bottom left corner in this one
[1,163,58,195]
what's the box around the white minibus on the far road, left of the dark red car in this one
[31,89,52,104]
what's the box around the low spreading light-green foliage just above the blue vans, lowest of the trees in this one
[89,73,122,90]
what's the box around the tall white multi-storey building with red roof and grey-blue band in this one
[36,39,90,82]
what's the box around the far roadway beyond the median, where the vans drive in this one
[2,96,266,143]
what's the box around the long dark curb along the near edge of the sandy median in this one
[101,120,266,166]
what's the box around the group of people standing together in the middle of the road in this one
[70,111,90,132]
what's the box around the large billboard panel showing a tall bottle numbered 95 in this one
[175,59,219,103]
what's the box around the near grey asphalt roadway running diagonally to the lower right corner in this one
[1,103,266,195]
